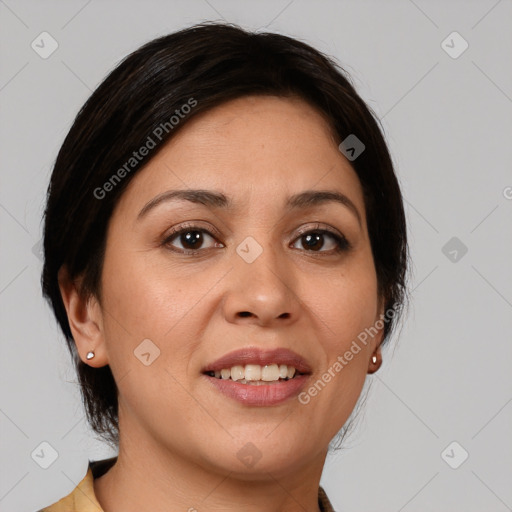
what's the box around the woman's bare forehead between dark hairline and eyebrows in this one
[115,96,364,216]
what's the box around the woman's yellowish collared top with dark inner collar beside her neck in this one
[38,457,335,512]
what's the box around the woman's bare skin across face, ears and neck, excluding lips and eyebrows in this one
[60,96,383,512]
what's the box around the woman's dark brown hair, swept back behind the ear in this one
[41,22,408,444]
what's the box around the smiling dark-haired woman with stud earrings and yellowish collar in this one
[38,24,407,512]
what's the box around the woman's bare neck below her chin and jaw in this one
[94,412,326,512]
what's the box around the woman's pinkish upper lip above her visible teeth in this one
[203,347,311,373]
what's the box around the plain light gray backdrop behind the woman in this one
[0,0,512,512]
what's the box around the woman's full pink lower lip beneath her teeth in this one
[205,375,309,407]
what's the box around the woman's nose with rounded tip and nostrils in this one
[223,241,300,327]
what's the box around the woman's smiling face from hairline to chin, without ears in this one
[92,97,382,478]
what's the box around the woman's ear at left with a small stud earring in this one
[58,267,108,368]
